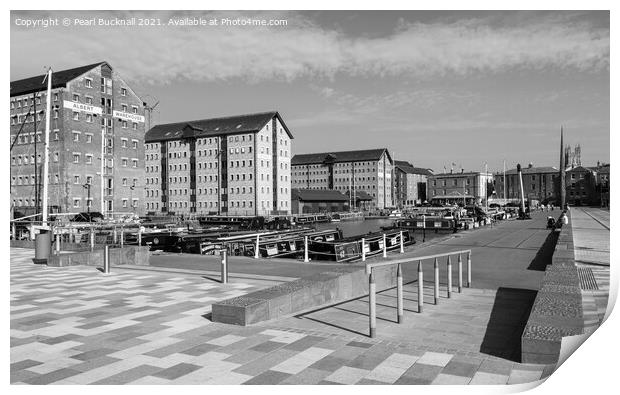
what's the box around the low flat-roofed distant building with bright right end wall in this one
[427,171,493,204]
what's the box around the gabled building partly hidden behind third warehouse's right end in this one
[394,160,433,207]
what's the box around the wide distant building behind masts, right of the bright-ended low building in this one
[493,164,560,203]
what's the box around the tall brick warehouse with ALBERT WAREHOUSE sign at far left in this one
[10,62,145,214]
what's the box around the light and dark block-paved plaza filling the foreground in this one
[10,211,608,384]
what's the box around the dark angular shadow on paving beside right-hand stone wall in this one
[480,287,537,362]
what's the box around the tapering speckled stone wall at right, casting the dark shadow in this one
[521,214,583,364]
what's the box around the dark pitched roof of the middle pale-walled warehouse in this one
[144,111,293,143]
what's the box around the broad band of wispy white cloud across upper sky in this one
[11,11,610,85]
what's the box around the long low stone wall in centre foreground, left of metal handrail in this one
[211,266,396,325]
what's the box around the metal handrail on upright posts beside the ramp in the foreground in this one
[366,250,472,338]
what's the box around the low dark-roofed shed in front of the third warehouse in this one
[291,189,349,214]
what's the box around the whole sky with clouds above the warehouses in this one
[10,11,610,172]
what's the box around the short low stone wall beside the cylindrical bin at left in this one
[47,246,150,267]
